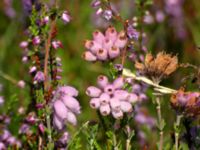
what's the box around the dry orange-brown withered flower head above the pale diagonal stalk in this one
[135,52,178,83]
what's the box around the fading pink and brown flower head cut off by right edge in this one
[171,89,200,117]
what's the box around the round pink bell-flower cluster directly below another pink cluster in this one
[86,75,138,119]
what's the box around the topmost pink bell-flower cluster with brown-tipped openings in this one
[83,27,127,62]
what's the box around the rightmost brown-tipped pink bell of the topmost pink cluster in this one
[114,31,127,48]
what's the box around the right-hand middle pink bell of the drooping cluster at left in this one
[62,95,80,114]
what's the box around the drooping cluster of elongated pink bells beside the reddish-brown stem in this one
[53,86,80,130]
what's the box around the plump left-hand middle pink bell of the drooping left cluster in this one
[53,100,67,120]
